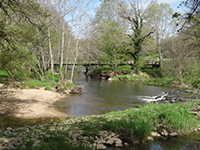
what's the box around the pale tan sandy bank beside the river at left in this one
[0,88,70,119]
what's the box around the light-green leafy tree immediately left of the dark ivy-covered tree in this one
[93,0,127,71]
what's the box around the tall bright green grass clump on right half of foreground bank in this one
[96,102,200,141]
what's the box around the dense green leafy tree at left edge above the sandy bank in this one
[0,0,44,79]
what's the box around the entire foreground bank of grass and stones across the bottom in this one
[0,101,200,150]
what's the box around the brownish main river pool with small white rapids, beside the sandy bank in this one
[56,74,172,117]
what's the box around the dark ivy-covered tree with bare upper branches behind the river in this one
[121,0,153,71]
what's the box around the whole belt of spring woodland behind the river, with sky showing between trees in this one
[0,0,200,88]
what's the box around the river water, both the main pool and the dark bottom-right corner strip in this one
[56,73,200,150]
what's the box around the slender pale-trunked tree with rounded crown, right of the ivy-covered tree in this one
[146,1,176,69]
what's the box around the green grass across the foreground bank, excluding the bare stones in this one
[3,101,200,150]
